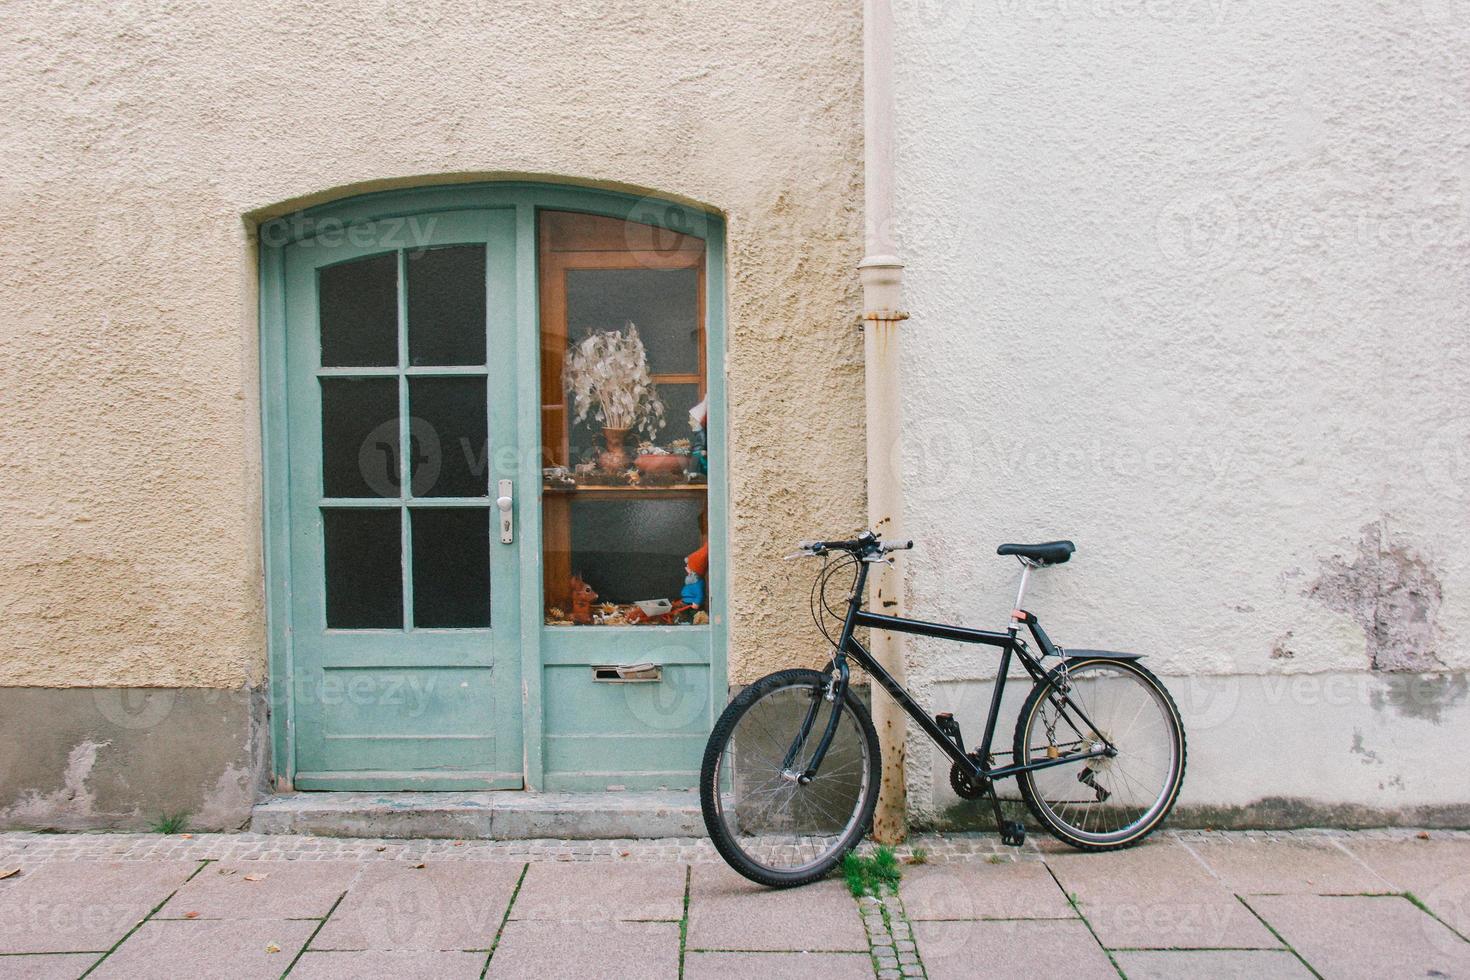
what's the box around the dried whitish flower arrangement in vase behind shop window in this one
[563,322,663,436]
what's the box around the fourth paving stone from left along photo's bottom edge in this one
[487,920,679,980]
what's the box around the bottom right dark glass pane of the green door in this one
[410,507,490,627]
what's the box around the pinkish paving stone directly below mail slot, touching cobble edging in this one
[510,864,686,921]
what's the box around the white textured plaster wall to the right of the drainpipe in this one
[895,0,1470,813]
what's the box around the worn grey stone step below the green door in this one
[250,790,707,840]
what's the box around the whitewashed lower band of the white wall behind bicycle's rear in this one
[908,671,1470,830]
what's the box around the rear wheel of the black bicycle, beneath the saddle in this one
[1014,660,1185,851]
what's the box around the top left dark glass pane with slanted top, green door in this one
[316,251,398,367]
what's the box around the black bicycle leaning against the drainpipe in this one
[700,530,1186,887]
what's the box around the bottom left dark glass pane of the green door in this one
[322,507,403,629]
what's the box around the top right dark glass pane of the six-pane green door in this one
[407,245,485,364]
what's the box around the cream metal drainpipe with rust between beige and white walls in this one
[858,0,908,843]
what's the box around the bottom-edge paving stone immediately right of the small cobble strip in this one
[914,918,1117,980]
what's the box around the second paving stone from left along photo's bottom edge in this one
[88,918,316,980]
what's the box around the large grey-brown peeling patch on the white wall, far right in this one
[1305,520,1444,671]
